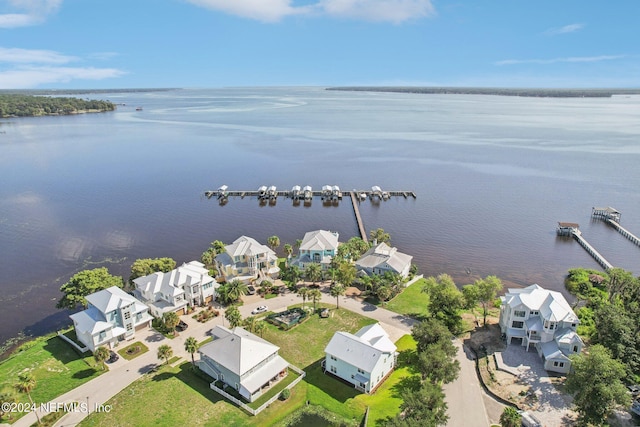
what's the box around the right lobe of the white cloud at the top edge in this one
[319,0,434,24]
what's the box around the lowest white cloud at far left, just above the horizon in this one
[0,67,126,89]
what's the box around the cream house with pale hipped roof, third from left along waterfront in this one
[216,236,280,283]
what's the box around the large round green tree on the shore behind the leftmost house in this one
[56,267,123,310]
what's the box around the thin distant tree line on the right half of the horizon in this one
[326,86,640,98]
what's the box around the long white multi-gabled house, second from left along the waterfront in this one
[133,261,220,317]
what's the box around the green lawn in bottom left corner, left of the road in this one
[0,335,105,422]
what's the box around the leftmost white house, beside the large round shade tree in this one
[69,286,151,351]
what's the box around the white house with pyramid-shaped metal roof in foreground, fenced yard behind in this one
[197,326,289,402]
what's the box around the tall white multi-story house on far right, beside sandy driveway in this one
[500,285,584,374]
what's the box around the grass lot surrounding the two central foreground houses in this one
[81,305,415,427]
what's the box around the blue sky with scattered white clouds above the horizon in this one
[0,0,640,89]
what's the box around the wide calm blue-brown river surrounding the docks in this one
[0,88,640,348]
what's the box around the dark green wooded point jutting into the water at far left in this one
[0,93,116,118]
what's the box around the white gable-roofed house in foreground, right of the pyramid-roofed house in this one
[322,323,398,393]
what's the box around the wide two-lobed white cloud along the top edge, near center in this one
[187,0,434,24]
